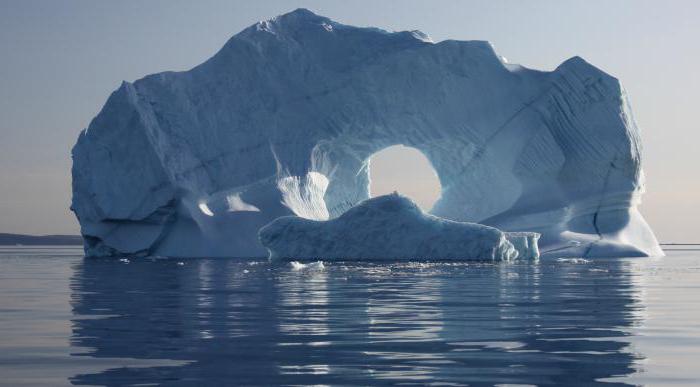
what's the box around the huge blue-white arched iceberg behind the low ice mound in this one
[72,9,662,256]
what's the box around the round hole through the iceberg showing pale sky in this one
[368,145,441,211]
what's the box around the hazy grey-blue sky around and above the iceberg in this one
[0,0,700,241]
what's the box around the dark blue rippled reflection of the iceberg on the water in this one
[67,259,642,385]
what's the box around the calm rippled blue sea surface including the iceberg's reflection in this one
[0,247,700,386]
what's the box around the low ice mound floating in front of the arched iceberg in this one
[260,194,539,261]
